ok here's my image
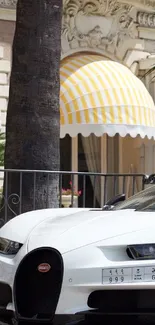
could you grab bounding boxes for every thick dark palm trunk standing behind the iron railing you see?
[4,0,62,216]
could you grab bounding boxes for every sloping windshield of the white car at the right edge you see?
[113,185,155,212]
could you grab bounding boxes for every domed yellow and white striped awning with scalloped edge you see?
[60,54,155,138]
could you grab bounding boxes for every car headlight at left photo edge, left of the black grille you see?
[0,237,22,255]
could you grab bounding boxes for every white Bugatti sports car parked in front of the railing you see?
[0,185,155,324]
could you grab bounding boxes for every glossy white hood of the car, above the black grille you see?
[27,210,155,254]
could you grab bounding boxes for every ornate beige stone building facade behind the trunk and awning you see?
[0,0,155,202]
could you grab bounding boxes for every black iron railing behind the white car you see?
[0,169,154,225]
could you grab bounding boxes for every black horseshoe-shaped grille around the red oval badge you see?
[14,248,63,321]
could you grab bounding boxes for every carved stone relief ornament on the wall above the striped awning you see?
[62,0,138,53]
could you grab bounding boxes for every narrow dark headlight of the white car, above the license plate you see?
[126,244,155,260]
